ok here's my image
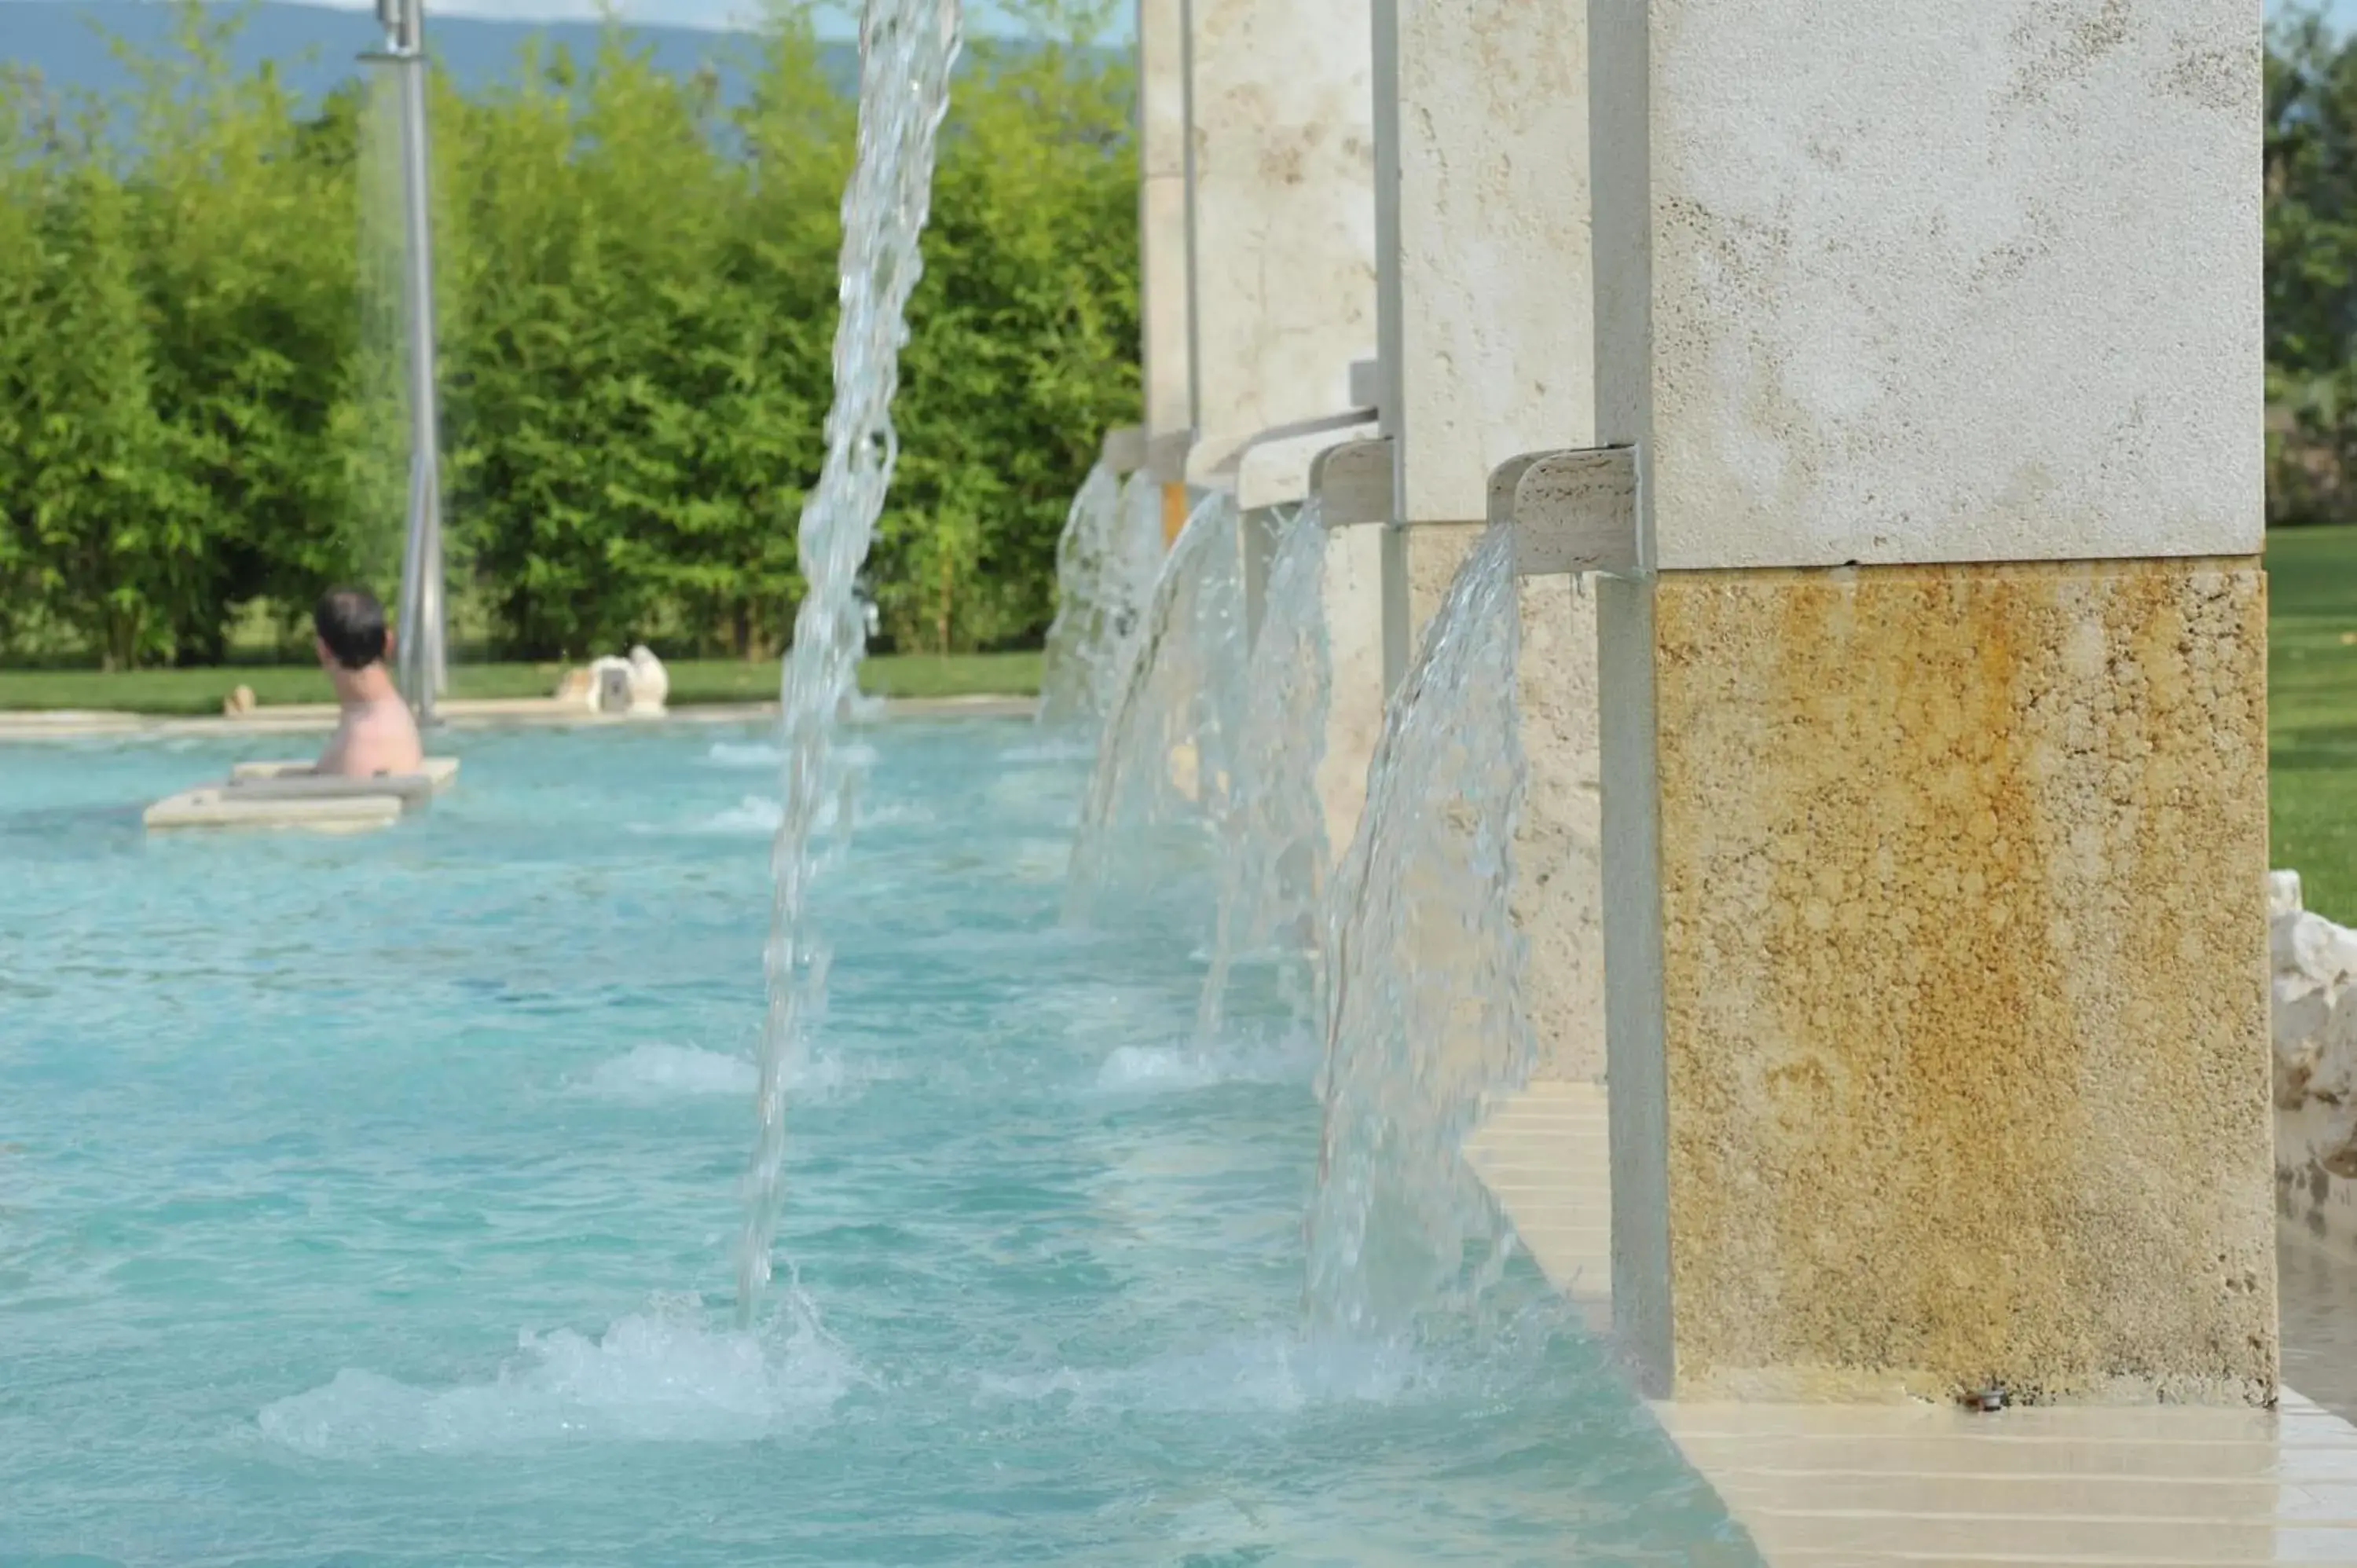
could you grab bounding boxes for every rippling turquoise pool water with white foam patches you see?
[0,724,1751,1568]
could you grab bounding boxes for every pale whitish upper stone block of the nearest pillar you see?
[1593,0,2265,570]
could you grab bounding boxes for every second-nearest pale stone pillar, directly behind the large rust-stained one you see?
[1360,0,1605,1078]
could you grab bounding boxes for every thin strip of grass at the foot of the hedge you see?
[0,653,1039,714]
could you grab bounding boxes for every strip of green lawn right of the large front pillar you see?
[2267,528,2357,925]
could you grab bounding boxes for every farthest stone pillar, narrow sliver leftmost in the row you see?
[1138,0,1195,542]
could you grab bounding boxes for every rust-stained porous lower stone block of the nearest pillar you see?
[1650,559,2277,1405]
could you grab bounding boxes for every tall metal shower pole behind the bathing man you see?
[363,0,450,724]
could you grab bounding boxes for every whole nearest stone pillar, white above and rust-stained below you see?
[1591,0,2277,1403]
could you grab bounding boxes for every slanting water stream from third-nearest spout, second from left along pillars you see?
[1068,495,1244,920]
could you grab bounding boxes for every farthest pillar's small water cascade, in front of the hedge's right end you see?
[1039,462,1162,726]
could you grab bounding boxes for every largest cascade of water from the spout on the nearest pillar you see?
[1308,528,1532,1337]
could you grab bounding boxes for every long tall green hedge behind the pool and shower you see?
[0,5,1138,667]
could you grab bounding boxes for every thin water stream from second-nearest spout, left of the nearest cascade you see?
[1195,500,1334,1040]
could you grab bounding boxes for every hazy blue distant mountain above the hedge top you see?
[0,0,858,101]
